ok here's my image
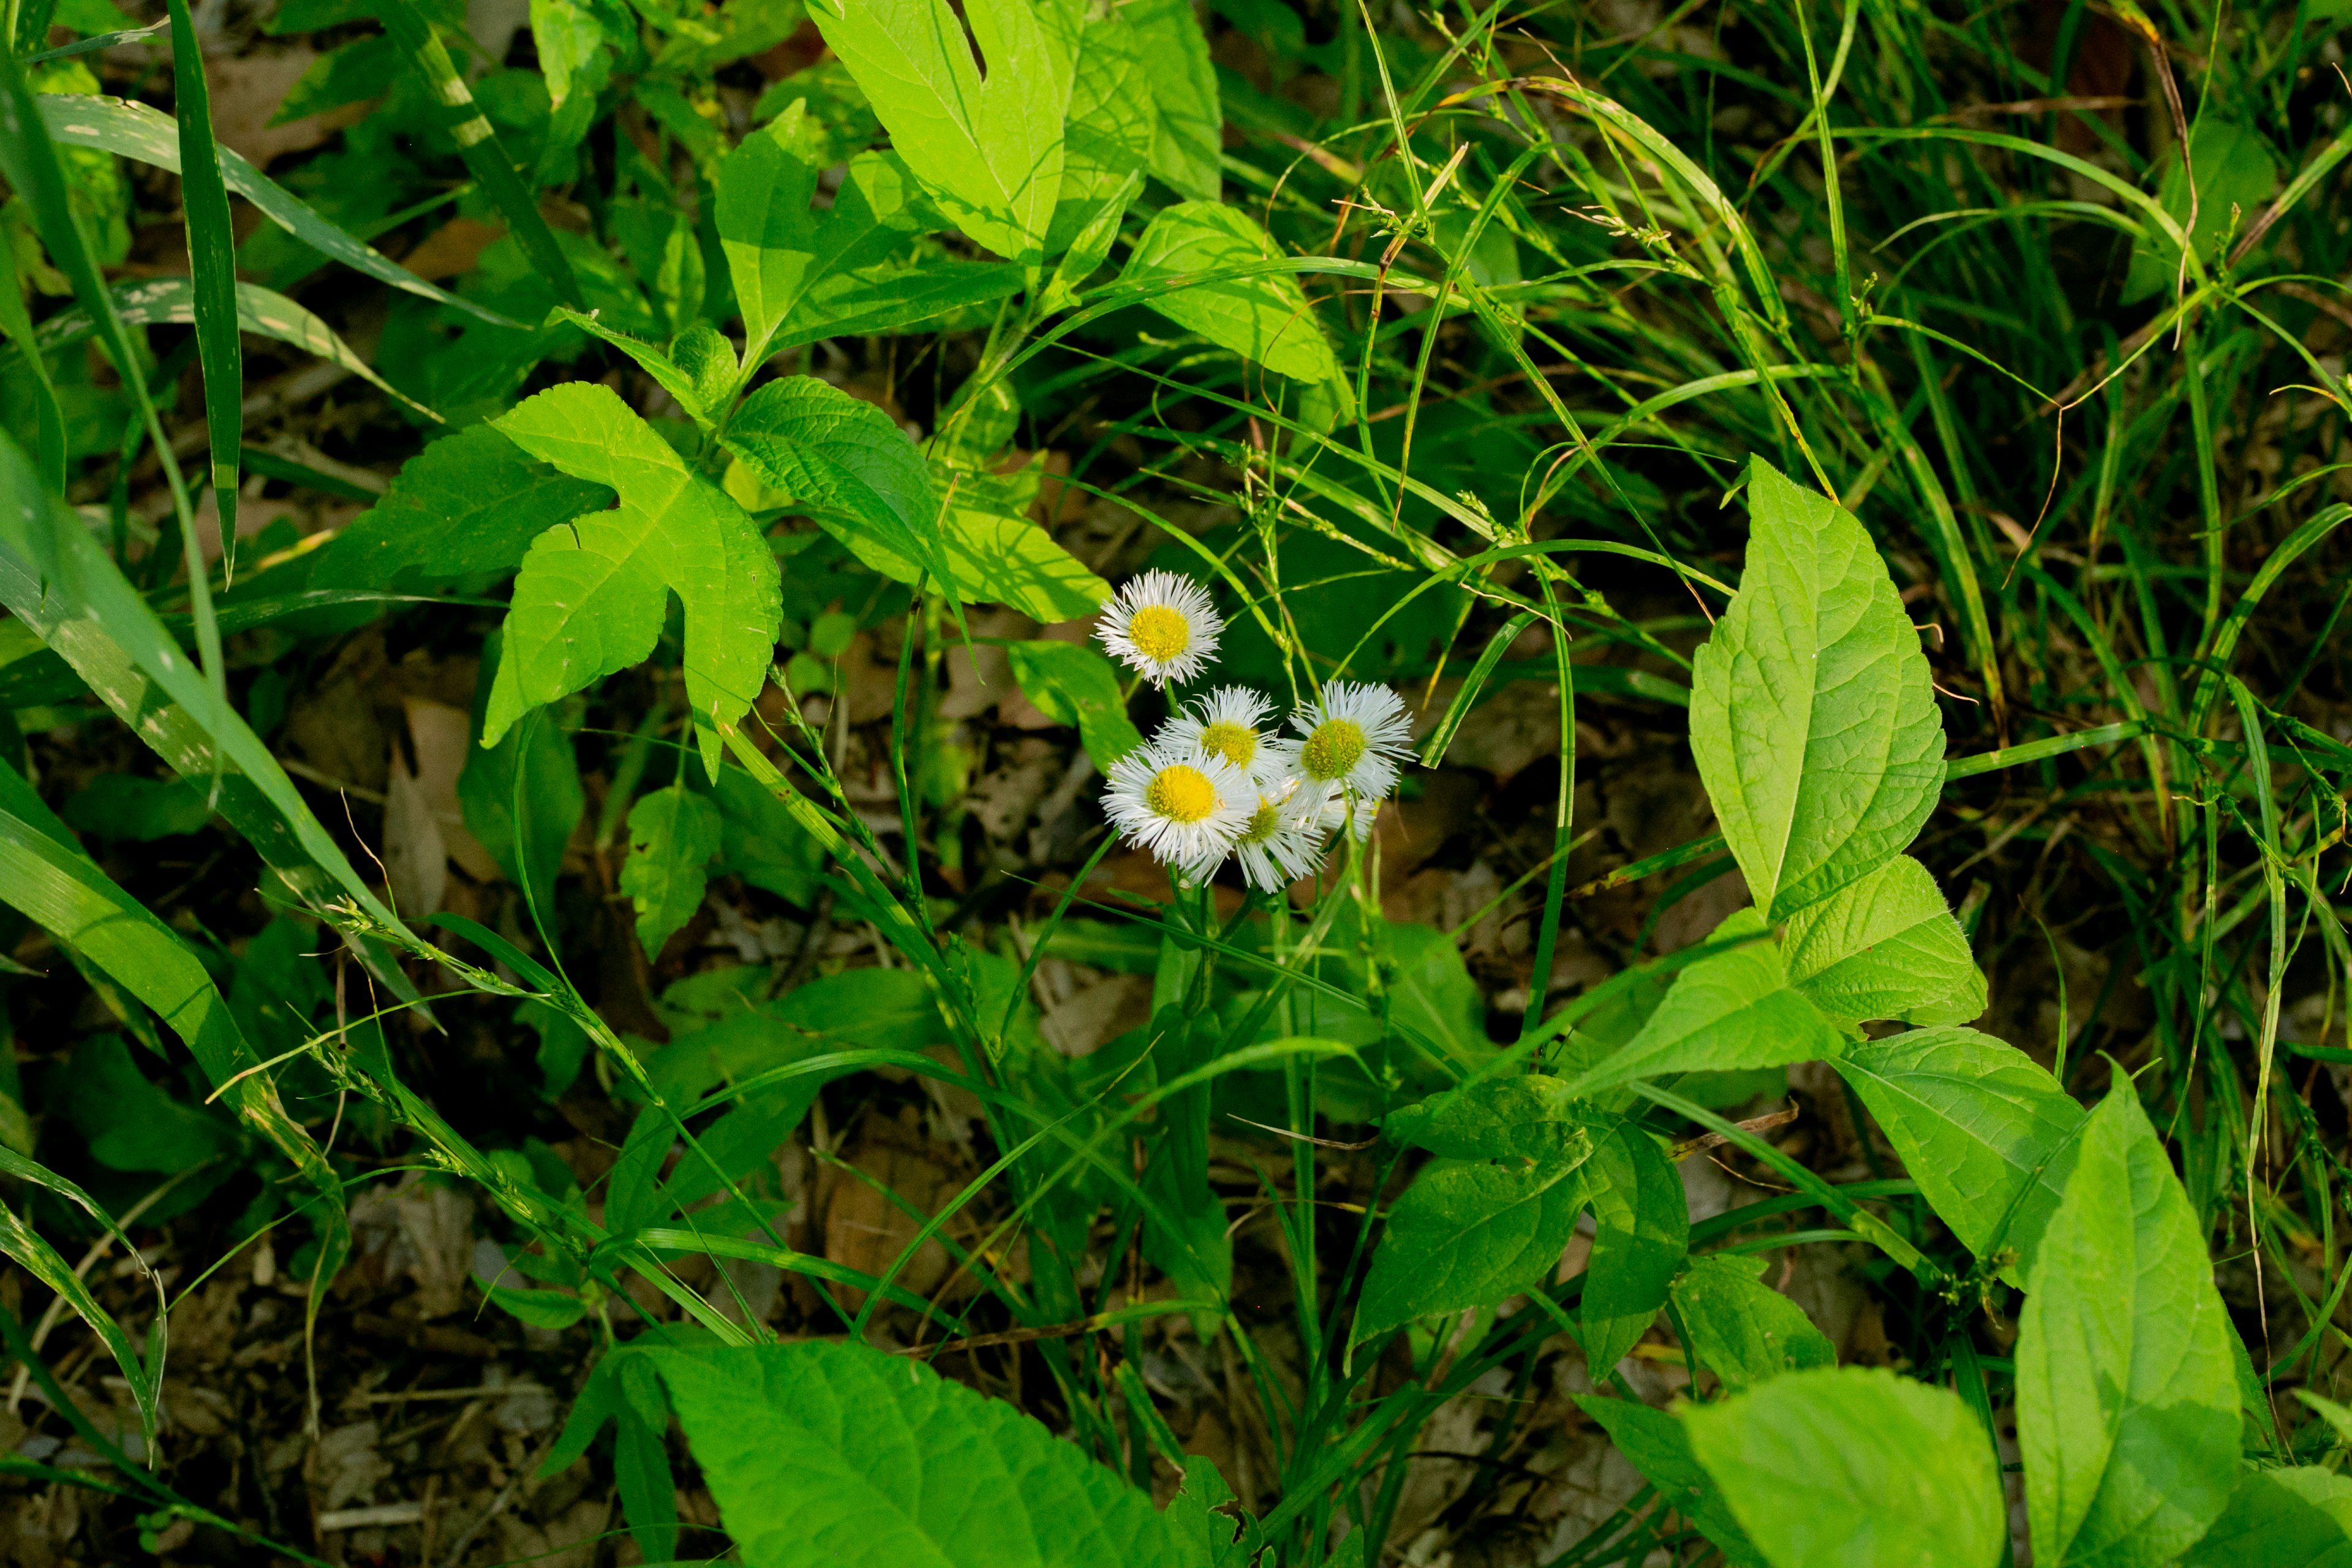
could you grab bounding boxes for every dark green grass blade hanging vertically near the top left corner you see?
[169,0,244,581]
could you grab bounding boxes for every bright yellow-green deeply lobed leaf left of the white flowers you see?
[482,381,783,778]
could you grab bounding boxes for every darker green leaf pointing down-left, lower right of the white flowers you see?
[1348,1145,1590,1344]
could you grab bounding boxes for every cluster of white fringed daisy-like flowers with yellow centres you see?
[1094,571,1414,893]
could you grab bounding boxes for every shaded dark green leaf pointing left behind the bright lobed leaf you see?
[279,426,614,592]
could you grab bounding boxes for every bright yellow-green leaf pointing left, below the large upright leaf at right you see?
[1574,910,1846,1096]
